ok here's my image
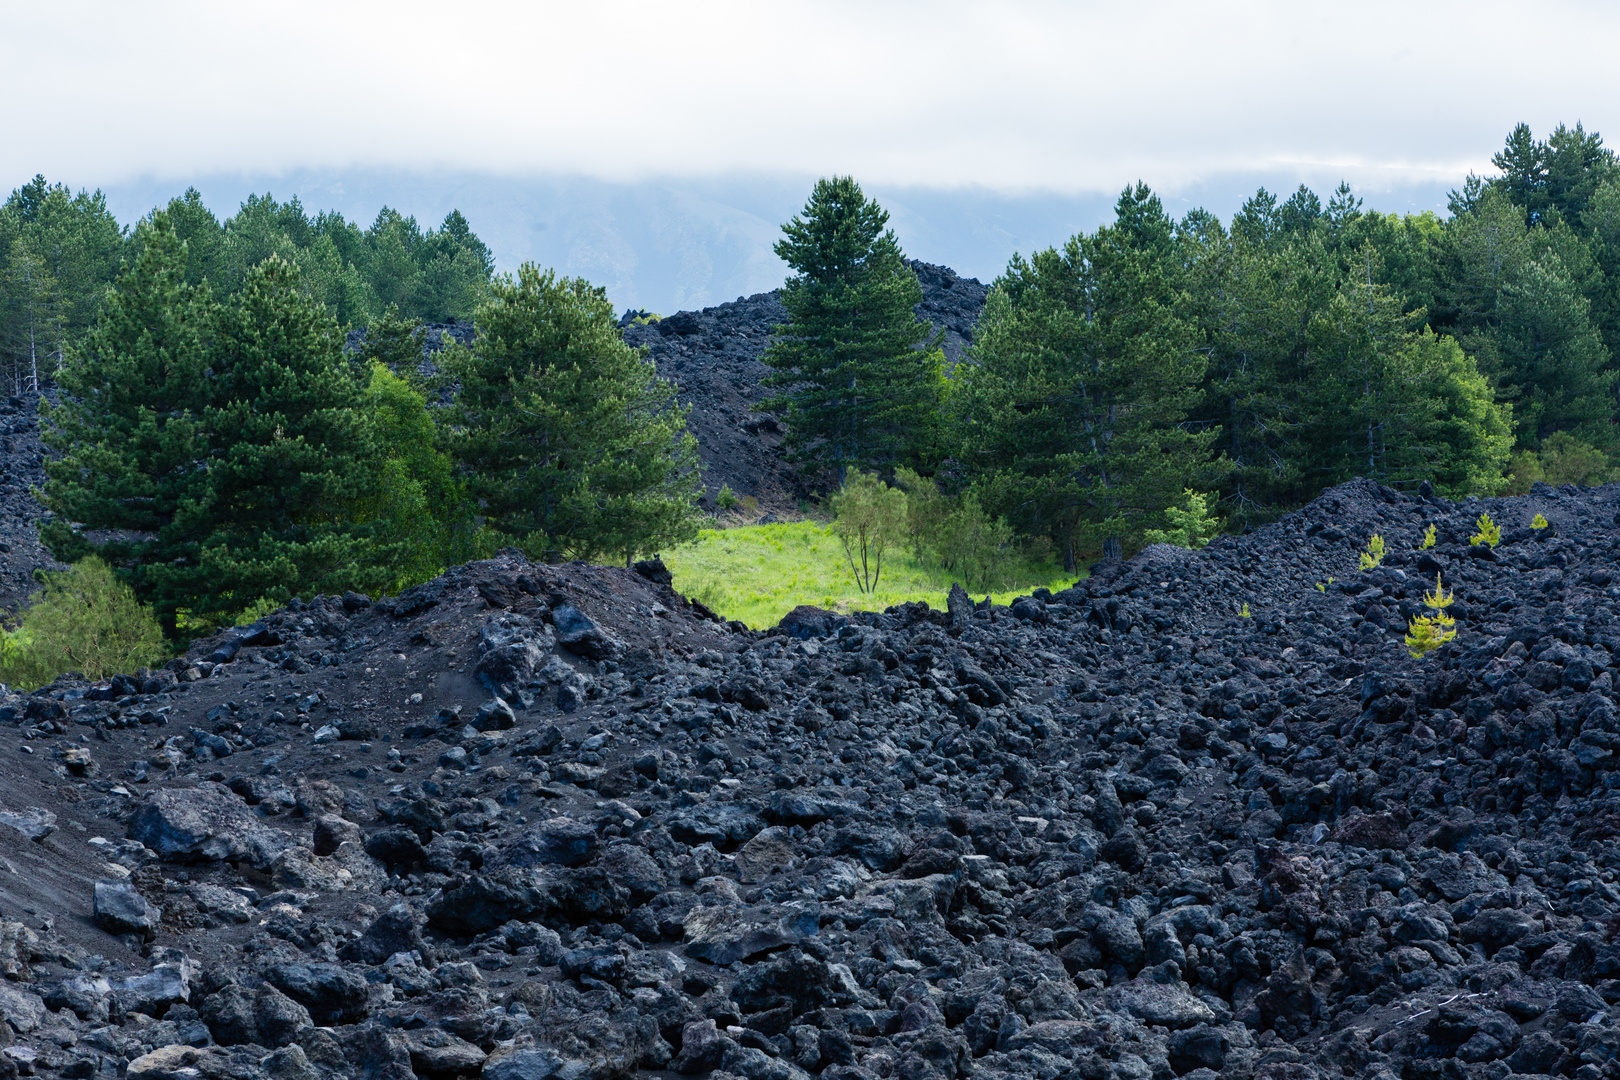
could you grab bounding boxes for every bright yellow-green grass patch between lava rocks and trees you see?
[664,521,1079,628]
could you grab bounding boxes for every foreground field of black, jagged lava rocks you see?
[0,483,1620,1080]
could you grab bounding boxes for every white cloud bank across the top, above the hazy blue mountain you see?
[0,0,1620,193]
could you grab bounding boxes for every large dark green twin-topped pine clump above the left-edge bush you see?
[41,214,431,635]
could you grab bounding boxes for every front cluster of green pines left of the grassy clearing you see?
[41,210,700,640]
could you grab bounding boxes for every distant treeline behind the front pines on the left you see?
[0,176,494,393]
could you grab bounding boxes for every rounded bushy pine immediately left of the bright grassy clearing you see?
[444,264,701,563]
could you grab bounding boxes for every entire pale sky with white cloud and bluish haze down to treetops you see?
[0,0,1620,309]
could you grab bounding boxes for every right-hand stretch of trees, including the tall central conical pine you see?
[766,125,1620,567]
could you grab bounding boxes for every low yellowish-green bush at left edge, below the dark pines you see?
[0,555,165,690]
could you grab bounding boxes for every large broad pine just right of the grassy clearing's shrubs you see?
[953,185,1217,568]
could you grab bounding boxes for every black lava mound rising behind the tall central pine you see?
[619,262,988,512]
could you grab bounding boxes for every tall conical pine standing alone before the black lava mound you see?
[761,176,944,473]
